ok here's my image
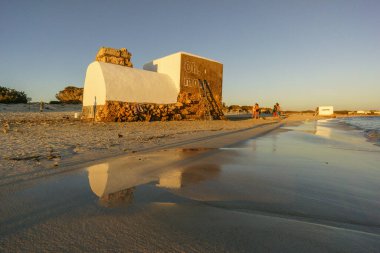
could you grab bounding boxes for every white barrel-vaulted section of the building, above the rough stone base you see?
[83,61,179,106]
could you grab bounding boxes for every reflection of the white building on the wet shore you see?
[87,154,220,207]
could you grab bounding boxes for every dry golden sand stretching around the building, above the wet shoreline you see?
[0,103,326,183]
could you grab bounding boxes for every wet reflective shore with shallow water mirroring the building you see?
[0,120,380,252]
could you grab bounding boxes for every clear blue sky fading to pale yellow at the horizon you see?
[0,0,380,110]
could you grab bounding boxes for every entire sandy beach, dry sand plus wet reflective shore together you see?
[0,106,380,252]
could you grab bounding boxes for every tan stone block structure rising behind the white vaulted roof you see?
[95,47,133,68]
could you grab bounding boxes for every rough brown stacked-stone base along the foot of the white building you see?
[82,92,222,122]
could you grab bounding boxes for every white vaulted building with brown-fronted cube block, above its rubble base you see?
[82,50,223,121]
